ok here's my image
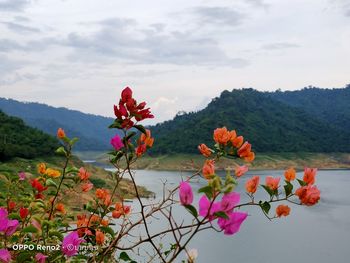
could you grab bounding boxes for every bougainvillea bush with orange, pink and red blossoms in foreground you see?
[0,88,320,263]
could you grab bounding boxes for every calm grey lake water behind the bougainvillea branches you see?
[107,170,350,263]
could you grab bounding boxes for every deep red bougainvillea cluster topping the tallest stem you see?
[114,87,154,129]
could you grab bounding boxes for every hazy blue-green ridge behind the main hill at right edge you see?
[269,84,350,130]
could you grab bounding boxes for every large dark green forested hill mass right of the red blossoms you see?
[151,87,350,154]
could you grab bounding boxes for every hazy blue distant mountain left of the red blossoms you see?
[0,98,115,151]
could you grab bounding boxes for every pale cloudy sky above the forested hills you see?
[0,0,350,124]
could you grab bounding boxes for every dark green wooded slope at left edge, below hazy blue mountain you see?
[0,111,59,161]
